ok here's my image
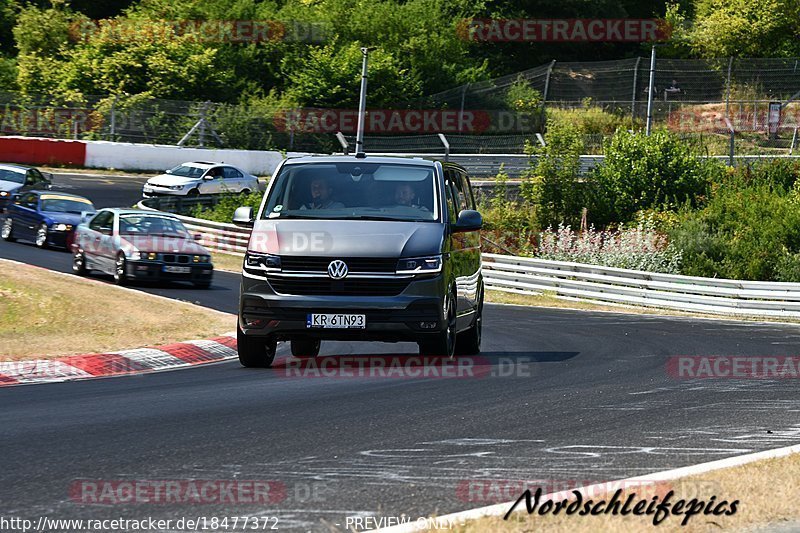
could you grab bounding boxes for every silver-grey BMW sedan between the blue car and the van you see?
[72,208,214,289]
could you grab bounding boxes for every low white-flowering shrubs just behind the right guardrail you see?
[536,218,682,274]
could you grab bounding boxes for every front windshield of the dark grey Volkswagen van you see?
[261,162,439,221]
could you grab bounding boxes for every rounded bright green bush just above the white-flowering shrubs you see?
[588,130,723,225]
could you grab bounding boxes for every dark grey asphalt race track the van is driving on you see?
[0,171,800,531]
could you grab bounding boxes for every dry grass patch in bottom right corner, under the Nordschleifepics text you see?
[432,448,800,533]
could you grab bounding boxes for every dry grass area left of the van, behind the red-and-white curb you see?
[0,261,236,361]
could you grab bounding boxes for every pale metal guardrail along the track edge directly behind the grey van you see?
[150,211,800,318]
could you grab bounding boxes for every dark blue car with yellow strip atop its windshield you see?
[0,191,96,249]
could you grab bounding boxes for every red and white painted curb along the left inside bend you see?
[0,332,237,387]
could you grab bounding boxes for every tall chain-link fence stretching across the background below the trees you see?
[0,57,800,155]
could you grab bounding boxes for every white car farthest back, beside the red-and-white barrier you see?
[142,161,260,198]
